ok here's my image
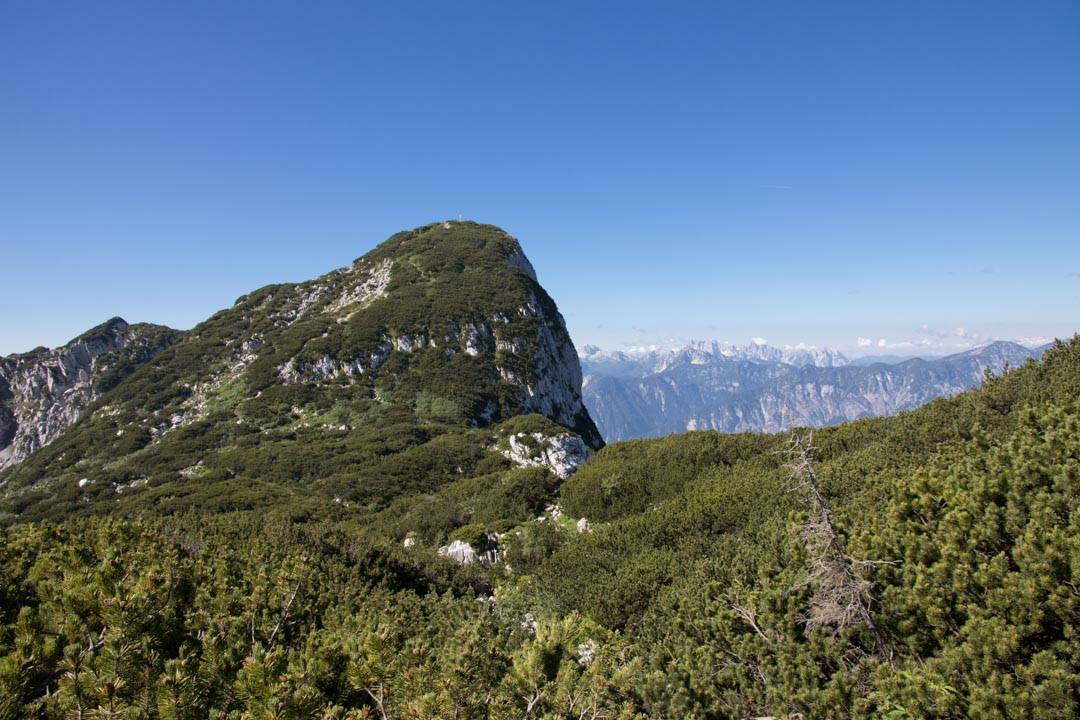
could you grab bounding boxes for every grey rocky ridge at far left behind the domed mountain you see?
[0,317,179,470]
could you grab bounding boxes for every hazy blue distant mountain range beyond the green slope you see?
[579,341,1049,443]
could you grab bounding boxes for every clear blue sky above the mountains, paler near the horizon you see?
[0,0,1080,353]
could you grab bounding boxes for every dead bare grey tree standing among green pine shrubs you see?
[787,432,892,663]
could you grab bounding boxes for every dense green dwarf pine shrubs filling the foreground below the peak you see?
[0,341,1080,718]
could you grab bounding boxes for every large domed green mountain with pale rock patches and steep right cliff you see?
[0,222,603,521]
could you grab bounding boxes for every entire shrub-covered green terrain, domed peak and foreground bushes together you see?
[0,223,1080,720]
